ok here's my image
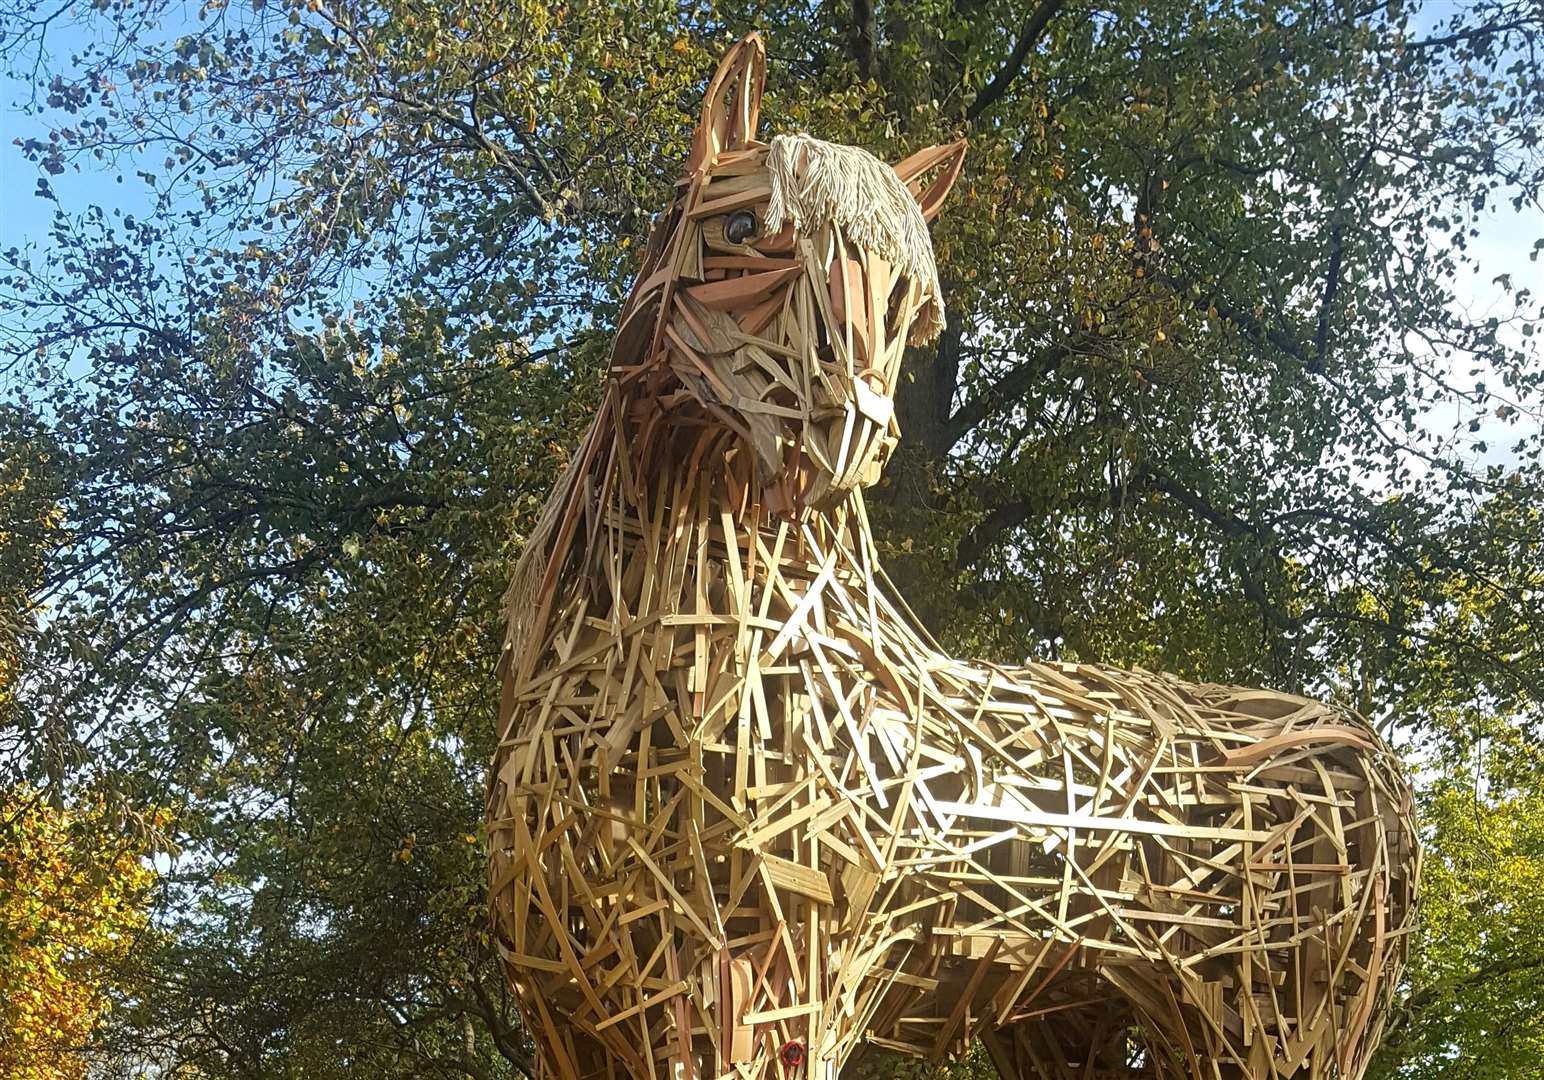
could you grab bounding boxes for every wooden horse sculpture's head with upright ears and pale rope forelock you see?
[611,34,965,513]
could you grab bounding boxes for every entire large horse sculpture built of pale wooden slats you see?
[488,36,1419,1080]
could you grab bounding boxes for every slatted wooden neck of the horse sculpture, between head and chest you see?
[505,384,936,684]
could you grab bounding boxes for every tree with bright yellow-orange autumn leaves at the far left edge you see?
[0,408,154,1080]
